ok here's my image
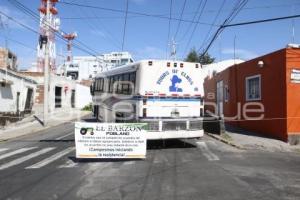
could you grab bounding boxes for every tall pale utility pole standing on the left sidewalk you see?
[43,0,50,126]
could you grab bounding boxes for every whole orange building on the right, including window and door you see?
[204,47,300,143]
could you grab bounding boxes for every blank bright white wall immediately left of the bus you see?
[75,83,92,109]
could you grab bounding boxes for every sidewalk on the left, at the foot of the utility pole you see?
[0,109,91,141]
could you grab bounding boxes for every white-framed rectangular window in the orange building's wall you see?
[246,75,261,101]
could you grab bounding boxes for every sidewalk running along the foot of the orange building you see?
[207,126,300,152]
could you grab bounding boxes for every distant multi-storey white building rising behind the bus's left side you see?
[57,52,133,80]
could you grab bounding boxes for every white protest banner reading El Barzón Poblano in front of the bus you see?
[75,122,147,158]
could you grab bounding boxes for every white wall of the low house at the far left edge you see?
[0,69,37,114]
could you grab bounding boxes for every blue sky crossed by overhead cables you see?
[0,0,300,68]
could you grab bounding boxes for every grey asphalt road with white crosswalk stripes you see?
[0,118,300,200]
